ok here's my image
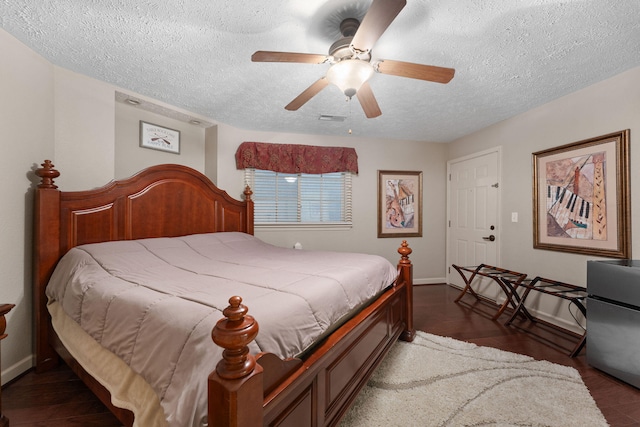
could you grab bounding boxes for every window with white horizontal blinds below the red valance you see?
[245,168,351,227]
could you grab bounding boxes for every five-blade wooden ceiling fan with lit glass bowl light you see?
[251,0,455,118]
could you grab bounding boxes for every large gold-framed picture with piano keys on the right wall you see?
[533,129,631,258]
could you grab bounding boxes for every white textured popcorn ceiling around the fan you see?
[0,0,640,142]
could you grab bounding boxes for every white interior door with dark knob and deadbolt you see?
[447,148,500,299]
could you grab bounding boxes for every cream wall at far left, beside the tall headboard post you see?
[0,30,54,382]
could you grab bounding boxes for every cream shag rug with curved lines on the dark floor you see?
[340,332,608,427]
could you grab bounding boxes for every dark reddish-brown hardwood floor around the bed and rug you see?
[2,285,640,427]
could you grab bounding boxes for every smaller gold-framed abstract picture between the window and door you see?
[378,170,422,237]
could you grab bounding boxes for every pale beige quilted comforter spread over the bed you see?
[47,232,397,426]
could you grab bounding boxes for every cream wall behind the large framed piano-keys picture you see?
[448,64,640,332]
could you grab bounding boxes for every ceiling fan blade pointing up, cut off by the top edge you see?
[351,0,407,52]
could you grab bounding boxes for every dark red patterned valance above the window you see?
[236,142,358,174]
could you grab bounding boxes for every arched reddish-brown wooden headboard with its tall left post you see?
[33,160,253,371]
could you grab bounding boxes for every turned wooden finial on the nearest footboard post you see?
[211,296,259,380]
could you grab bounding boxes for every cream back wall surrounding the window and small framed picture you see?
[218,125,447,283]
